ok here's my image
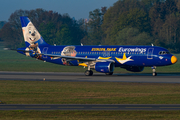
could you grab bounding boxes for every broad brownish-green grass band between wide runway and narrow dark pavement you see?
[0,80,180,104]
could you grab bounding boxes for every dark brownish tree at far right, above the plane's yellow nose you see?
[149,0,180,52]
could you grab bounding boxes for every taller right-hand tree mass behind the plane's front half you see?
[83,0,180,52]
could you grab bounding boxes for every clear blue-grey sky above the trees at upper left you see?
[0,0,118,21]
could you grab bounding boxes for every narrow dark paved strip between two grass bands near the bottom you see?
[0,104,180,111]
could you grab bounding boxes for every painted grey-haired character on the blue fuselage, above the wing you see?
[61,46,77,65]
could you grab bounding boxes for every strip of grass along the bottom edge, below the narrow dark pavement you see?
[0,110,180,120]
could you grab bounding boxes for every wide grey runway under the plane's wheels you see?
[0,72,180,83]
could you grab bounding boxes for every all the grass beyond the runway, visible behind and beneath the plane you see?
[0,49,180,73]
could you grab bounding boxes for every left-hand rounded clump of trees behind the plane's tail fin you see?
[0,9,85,48]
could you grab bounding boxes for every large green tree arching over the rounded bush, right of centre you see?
[101,0,151,44]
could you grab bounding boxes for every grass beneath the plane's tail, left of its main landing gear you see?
[0,50,84,72]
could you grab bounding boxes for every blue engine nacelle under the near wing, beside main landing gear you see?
[95,62,114,73]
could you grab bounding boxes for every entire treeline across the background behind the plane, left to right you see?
[0,0,180,52]
